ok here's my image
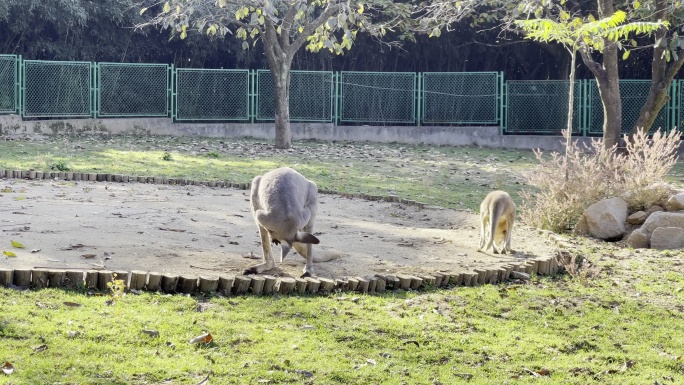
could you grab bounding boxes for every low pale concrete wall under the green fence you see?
[0,115,587,151]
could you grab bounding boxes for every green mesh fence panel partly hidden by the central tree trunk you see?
[255,70,335,122]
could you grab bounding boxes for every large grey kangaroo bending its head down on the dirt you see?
[244,167,339,278]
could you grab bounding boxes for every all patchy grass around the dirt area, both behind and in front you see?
[0,137,684,385]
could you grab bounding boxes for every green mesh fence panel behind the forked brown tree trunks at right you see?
[586,79,673,134]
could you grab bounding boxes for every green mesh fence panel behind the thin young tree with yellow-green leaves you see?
[504,80,585,134]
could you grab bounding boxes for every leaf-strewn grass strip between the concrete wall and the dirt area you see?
[0,136,536,210]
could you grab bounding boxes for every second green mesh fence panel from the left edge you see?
[22,60,94,118]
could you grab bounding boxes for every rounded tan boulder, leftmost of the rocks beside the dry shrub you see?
[580,197,627,239]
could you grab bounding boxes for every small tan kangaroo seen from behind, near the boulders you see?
[477,191,515,254]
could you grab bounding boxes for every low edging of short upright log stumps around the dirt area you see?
[0,170,572,296]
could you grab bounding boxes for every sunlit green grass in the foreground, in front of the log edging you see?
[0,250,684,384]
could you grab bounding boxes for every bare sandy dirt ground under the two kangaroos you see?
[0,179,554,278]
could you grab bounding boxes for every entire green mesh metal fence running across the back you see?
[0,55,684,135]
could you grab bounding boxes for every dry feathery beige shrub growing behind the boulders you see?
[520,130,680,232]
